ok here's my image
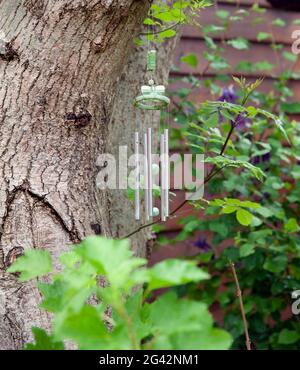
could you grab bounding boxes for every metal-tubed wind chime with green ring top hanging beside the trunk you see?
[134,50,170,221]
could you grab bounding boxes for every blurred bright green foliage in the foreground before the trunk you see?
[10,236,232,350]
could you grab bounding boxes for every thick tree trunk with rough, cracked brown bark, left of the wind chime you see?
[0,0,148,349]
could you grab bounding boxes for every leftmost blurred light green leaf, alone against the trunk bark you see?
[7,249,52,281]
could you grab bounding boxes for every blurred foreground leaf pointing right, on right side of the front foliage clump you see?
[148,259,209,290]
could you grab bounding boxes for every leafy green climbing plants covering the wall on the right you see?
[168,4,300,349]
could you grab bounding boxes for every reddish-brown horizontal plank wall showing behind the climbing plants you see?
[151,0,300,263]
